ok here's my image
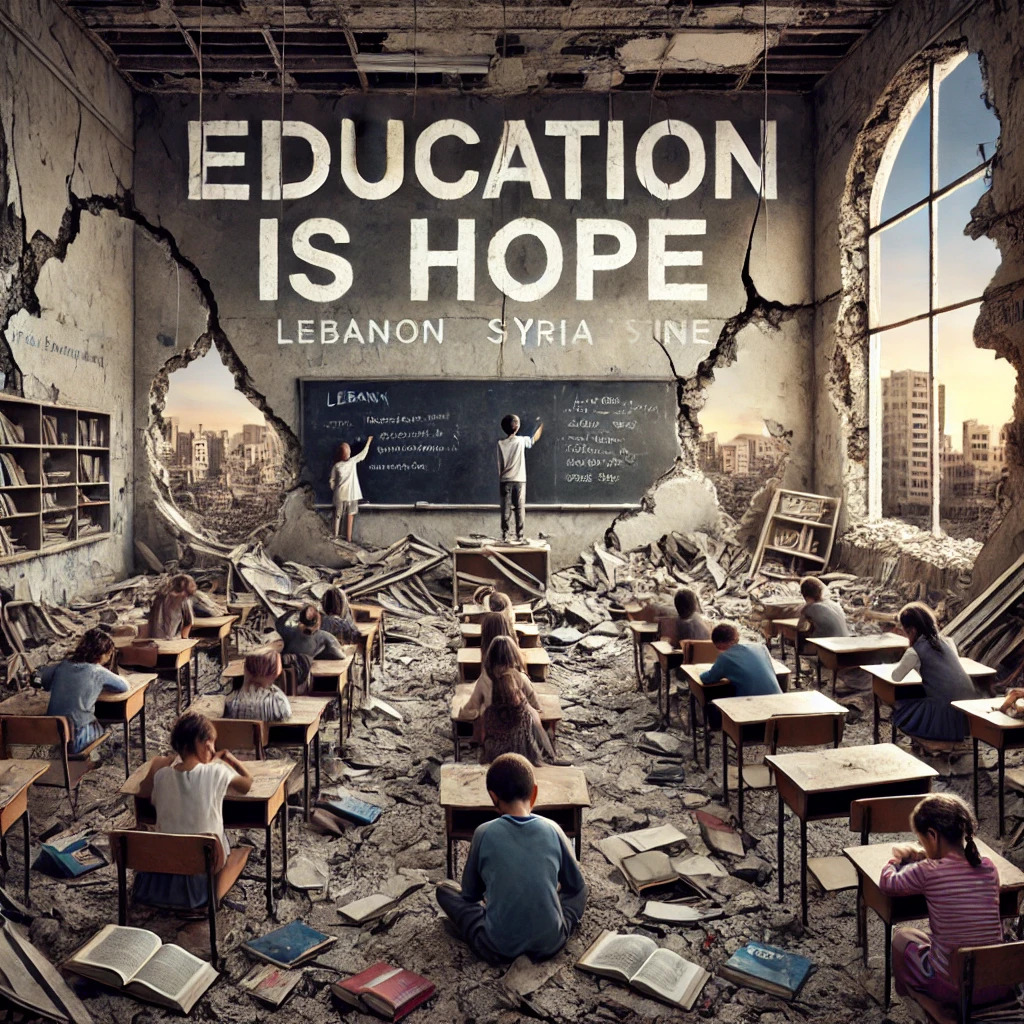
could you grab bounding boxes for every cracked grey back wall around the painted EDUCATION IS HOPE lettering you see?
[134,94,812,560]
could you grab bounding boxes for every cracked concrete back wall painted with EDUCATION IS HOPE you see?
[135,94,813,560]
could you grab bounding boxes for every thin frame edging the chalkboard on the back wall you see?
[296,375,673,512]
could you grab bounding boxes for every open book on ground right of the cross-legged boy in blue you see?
[577,931,711,1010]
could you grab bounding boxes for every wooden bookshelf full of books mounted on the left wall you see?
[0,394,111,564]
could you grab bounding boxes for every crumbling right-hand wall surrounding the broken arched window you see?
[815,0,1024,592]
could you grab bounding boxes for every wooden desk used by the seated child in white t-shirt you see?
[121,758,295,914]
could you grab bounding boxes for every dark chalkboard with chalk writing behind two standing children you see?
[299,379,679,505]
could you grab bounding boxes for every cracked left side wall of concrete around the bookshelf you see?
[0,0,134,600]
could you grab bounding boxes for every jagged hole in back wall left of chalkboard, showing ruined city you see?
[157,347,293,542]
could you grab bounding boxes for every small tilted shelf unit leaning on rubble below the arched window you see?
[751,488,842,575]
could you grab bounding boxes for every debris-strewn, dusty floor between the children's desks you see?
[14,618,1021,1024]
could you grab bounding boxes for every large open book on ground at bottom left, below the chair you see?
[63,925,217,1014]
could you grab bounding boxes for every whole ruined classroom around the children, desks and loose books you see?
[6,0,1024,1024]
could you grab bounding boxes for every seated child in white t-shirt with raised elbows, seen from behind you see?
[135,711,253,909]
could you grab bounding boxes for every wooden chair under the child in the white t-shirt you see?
[109,829,252,968]
